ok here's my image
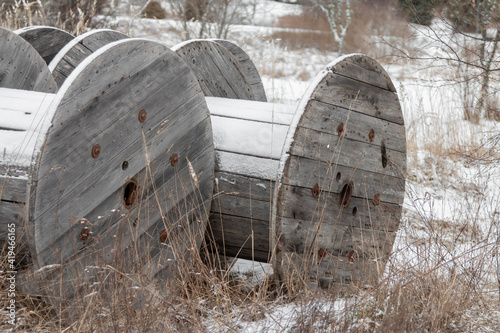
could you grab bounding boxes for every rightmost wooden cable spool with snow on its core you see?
[175,41,406,288]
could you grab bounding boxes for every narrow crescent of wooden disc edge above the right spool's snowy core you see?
[212,39,267,102]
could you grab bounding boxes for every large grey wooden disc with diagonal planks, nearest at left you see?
[30,39,214,303]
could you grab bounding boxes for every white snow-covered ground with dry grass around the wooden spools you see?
[0,1,500,332]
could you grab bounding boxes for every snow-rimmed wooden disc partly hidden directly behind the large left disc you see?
[49,29,128,86]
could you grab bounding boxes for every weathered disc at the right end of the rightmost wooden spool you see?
[272,55,406,288]
